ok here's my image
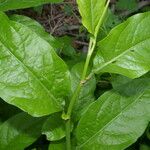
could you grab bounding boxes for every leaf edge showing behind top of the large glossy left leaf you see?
[9,15,61,53]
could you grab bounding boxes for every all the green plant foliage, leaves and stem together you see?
[0,0,150,150]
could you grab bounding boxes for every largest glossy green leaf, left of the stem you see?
[0,12,70,116]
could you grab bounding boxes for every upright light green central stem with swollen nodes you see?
[64,0,110,150]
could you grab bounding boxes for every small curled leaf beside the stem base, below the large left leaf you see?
[42,113,65,141]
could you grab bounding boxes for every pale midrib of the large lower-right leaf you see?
[79,91,145,148]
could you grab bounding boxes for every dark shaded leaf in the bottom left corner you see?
[0,113,45,150]
